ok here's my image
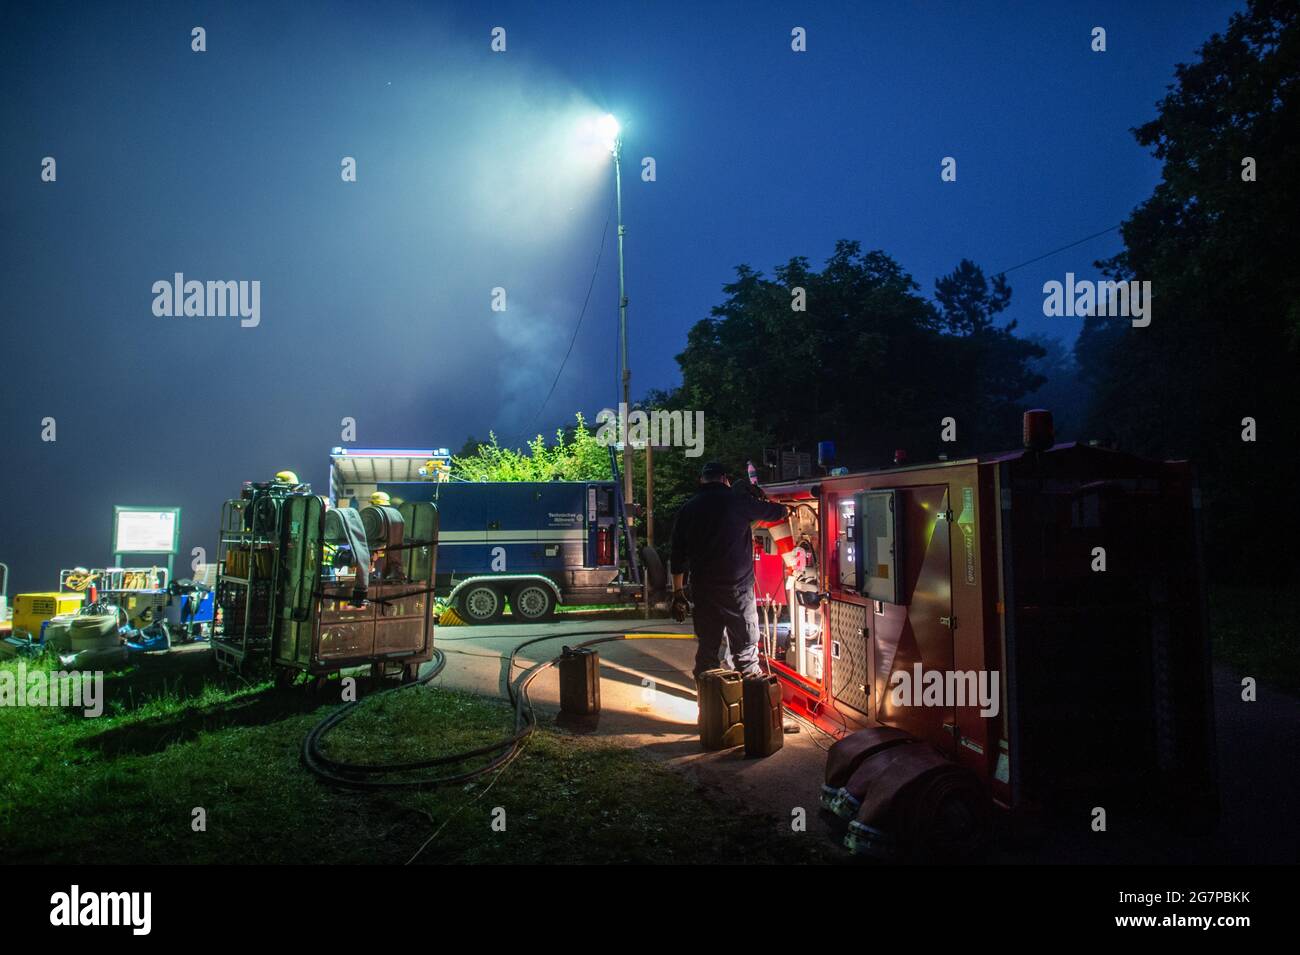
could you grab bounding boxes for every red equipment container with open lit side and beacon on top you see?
[757,418,1216,808]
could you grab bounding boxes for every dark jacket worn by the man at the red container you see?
[672,483,785,587]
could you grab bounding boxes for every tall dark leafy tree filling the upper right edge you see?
[1075,0,1300,573]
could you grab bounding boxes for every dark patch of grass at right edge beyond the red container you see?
[1209,587,1300,693]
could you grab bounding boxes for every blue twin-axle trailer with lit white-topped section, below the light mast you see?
[329,448,642,624]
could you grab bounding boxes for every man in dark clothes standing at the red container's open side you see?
[672,461,787,680]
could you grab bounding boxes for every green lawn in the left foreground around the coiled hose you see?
[0,652,839,863]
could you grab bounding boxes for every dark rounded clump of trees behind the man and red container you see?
[673,240,1040,466]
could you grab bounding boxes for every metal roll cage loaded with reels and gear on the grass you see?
[212,481,438,681]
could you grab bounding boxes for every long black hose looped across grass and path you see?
[302,628,680,789]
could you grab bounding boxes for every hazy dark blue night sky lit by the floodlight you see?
[0,3,1238,594]
